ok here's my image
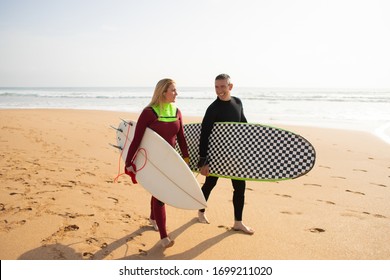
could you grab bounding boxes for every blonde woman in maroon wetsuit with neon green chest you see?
[125,79,189,248]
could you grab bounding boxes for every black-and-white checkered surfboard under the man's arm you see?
[176,123,316,181]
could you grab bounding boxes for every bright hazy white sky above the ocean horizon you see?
[0,0,390,88]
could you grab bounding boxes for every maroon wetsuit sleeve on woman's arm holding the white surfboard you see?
[126,108,156,167]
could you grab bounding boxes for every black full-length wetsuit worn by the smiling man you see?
[199,96,247,221]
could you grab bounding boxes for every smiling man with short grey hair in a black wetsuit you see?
[198,74,255,234]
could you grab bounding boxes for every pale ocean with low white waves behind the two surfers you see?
[0,87,390,144]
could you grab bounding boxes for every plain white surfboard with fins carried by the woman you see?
[116,121,206,210]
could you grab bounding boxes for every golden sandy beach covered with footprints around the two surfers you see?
[0,110,390,260]
